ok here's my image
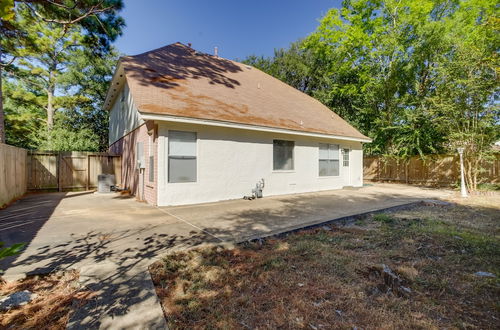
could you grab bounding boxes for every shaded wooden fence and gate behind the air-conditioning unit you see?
[27,151,121,191]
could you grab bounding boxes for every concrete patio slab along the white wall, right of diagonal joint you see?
[161,184,452,242]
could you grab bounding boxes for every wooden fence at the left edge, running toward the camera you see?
[0,143,27,207]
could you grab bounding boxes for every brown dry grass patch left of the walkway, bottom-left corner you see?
[0,271,90,330]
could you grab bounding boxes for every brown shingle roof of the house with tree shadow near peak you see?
[108,43,369,141]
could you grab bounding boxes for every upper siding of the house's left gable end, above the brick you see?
[109,84,144,145]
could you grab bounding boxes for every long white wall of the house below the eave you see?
[157,122,363,206]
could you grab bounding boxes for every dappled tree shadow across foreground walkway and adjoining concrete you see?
[7,225,218,329]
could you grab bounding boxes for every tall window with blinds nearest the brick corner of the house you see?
[168,131,196,183]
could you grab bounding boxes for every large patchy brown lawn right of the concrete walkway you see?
[151,195,500,329]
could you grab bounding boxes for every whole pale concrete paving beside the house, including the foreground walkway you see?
[0,184,450,329]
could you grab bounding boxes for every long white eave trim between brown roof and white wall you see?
[139,111,372,143]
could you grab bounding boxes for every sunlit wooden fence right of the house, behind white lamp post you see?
[363,155,500,186]
